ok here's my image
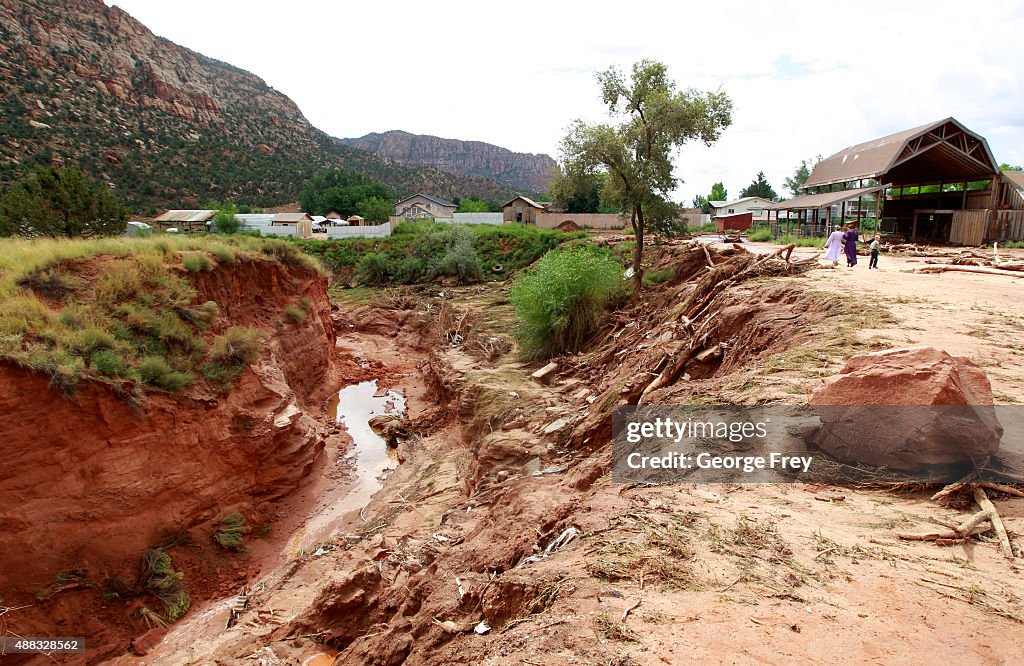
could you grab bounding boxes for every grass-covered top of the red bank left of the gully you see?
[0,236,318,400]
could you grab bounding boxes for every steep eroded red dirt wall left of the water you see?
[0,257,336,663]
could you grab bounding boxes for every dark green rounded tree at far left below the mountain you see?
[0,167,128,238]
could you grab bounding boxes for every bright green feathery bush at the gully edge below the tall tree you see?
[509,247,626,359]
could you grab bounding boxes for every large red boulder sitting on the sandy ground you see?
[808,347,1002,472]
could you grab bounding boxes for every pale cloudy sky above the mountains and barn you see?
[108,0,1024,201]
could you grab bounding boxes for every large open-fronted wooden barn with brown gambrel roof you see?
[766,118,1024,245]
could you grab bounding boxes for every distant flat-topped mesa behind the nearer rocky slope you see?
[341,130,555,193]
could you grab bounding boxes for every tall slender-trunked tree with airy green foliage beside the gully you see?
[561,59,732,292]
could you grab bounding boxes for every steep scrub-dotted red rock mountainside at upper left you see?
[0,0,512,212]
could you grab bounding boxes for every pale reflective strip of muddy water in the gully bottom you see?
[289,379,406,556]
